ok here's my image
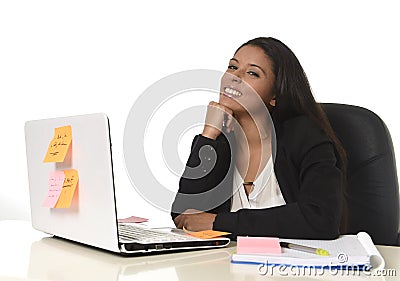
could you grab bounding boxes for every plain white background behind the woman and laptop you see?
[0,0,400,224]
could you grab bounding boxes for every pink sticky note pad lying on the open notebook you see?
[237,236,282,254]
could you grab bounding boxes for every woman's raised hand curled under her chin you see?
[202,101,233,140]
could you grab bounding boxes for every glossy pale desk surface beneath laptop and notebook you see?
[0,221,400,281]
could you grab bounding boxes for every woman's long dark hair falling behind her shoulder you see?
[236,37,347,233]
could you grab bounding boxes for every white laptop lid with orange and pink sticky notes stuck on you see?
[25,113,119,252]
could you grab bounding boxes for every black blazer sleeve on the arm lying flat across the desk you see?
[213,118,342,239]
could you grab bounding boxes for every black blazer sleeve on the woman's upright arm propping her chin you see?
[171,134,232,219]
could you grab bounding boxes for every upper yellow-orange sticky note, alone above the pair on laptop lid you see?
[43,126,72,162]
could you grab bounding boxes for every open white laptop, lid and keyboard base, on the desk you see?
[25,113,230,255]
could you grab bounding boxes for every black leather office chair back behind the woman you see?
[321,103,400,245]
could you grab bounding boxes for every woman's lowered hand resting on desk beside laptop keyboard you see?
[174,209,217,231]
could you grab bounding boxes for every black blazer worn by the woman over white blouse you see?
[171,116,342,239]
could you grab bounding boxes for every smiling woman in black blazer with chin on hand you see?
[172,37,345,239]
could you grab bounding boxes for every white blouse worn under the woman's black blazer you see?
[231,157,286,212]
